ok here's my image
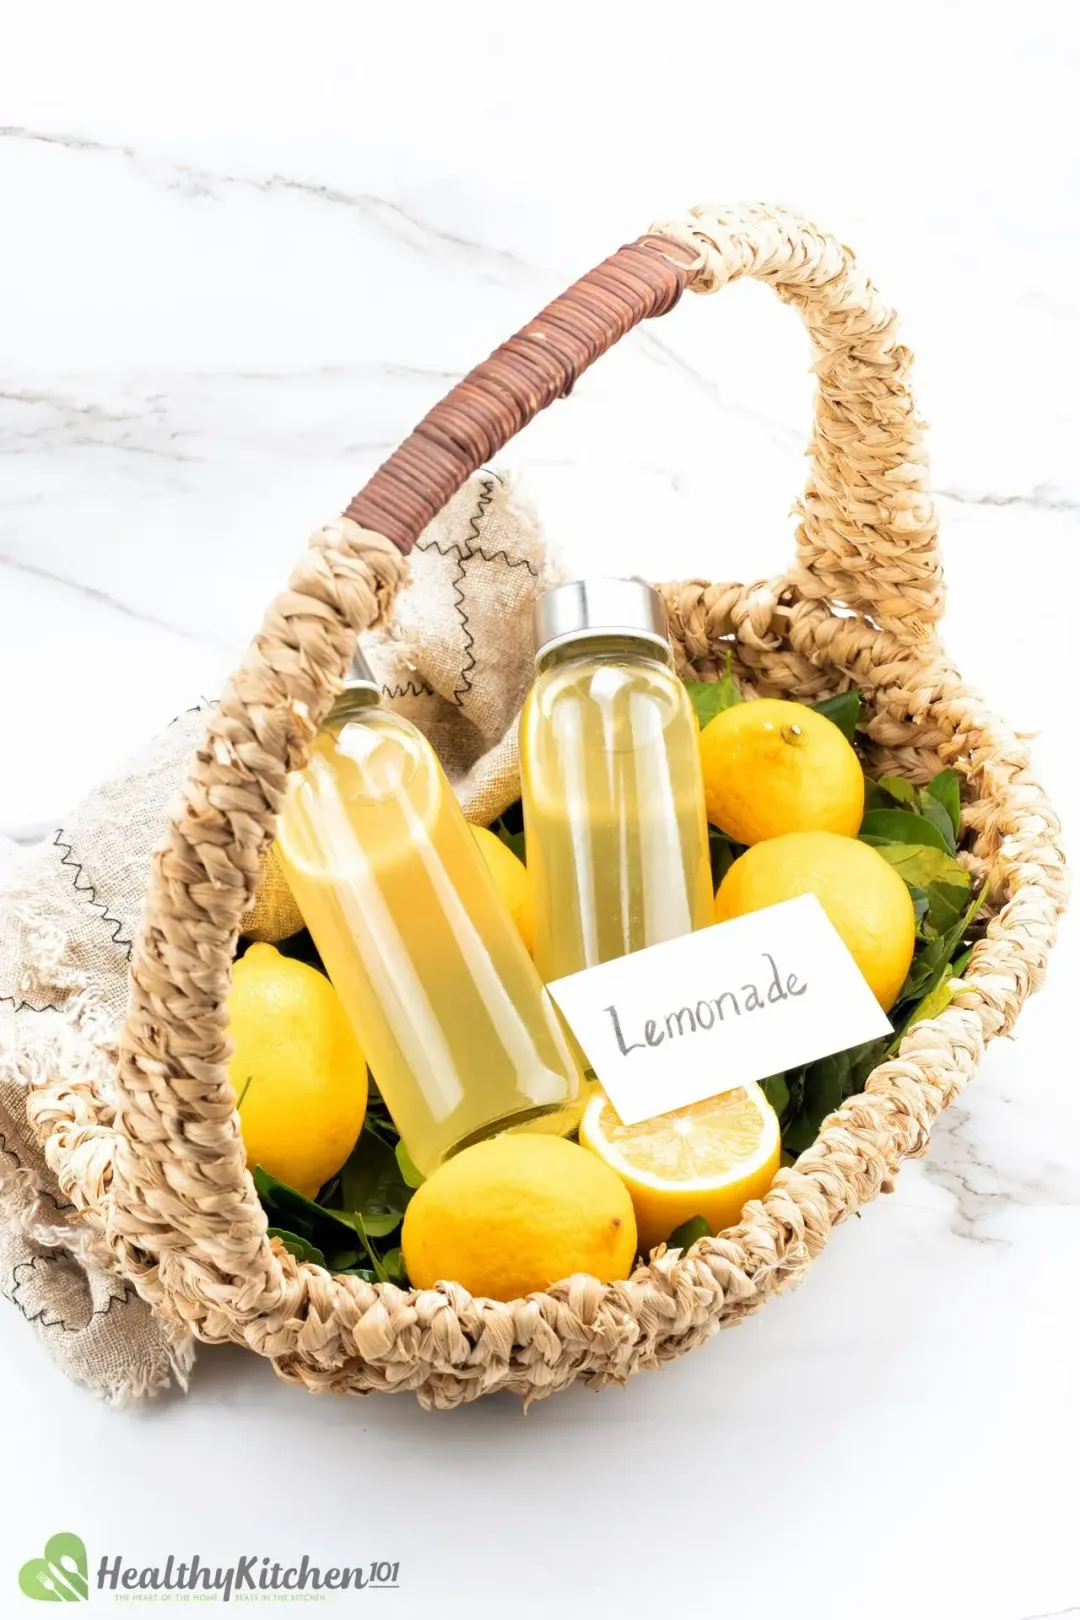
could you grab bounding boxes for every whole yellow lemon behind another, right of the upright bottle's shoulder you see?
[699,698,865,844]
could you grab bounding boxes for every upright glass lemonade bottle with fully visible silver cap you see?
[521,578,712,982]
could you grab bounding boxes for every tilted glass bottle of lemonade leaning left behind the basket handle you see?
[279,654,583,1175]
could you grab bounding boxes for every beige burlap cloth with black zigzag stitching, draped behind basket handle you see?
[0,471,557,1403]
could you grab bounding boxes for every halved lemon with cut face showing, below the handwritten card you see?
[580,1085,780,1254]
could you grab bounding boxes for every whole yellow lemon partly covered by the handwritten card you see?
[716,833,915,1013]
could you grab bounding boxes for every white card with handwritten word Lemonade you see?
[547,894,892,1124]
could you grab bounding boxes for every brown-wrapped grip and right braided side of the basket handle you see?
[345,207,944,645]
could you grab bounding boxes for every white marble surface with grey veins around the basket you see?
[0,9,1080,1620]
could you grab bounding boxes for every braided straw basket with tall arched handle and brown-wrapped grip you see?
[34,207,1065,1406]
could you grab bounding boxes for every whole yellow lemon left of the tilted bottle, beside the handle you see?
[228,944,368,1197]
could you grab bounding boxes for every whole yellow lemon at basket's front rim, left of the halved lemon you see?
[402,1136,638,1299]
